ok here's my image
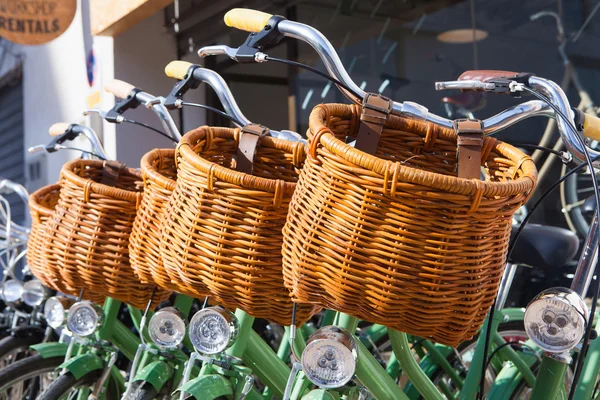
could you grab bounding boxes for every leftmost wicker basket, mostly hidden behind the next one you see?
[27,184,104,304]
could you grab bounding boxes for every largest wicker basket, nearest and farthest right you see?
[283,104,537,346]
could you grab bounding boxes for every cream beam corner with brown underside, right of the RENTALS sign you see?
[90,0,173,36]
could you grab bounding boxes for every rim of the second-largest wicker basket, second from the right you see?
[176,125,306,194]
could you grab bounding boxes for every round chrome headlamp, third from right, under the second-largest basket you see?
[189,307,238,355]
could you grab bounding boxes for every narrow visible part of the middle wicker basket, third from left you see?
[129,149,177,297]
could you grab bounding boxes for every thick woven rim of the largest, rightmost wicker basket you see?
[308,103,537,196]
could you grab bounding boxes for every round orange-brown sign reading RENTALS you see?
[0,0,77,44]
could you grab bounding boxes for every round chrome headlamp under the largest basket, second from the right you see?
[302,326,358,389]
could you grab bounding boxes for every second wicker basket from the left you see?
[41,160,161,308]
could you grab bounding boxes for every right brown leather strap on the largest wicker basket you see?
[454,119,483,179]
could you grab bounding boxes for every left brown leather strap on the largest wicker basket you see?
[354,93,394,154]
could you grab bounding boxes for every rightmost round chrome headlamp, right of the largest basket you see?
[524,288,589,353]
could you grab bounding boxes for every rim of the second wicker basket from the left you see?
[60,159,142,202]
